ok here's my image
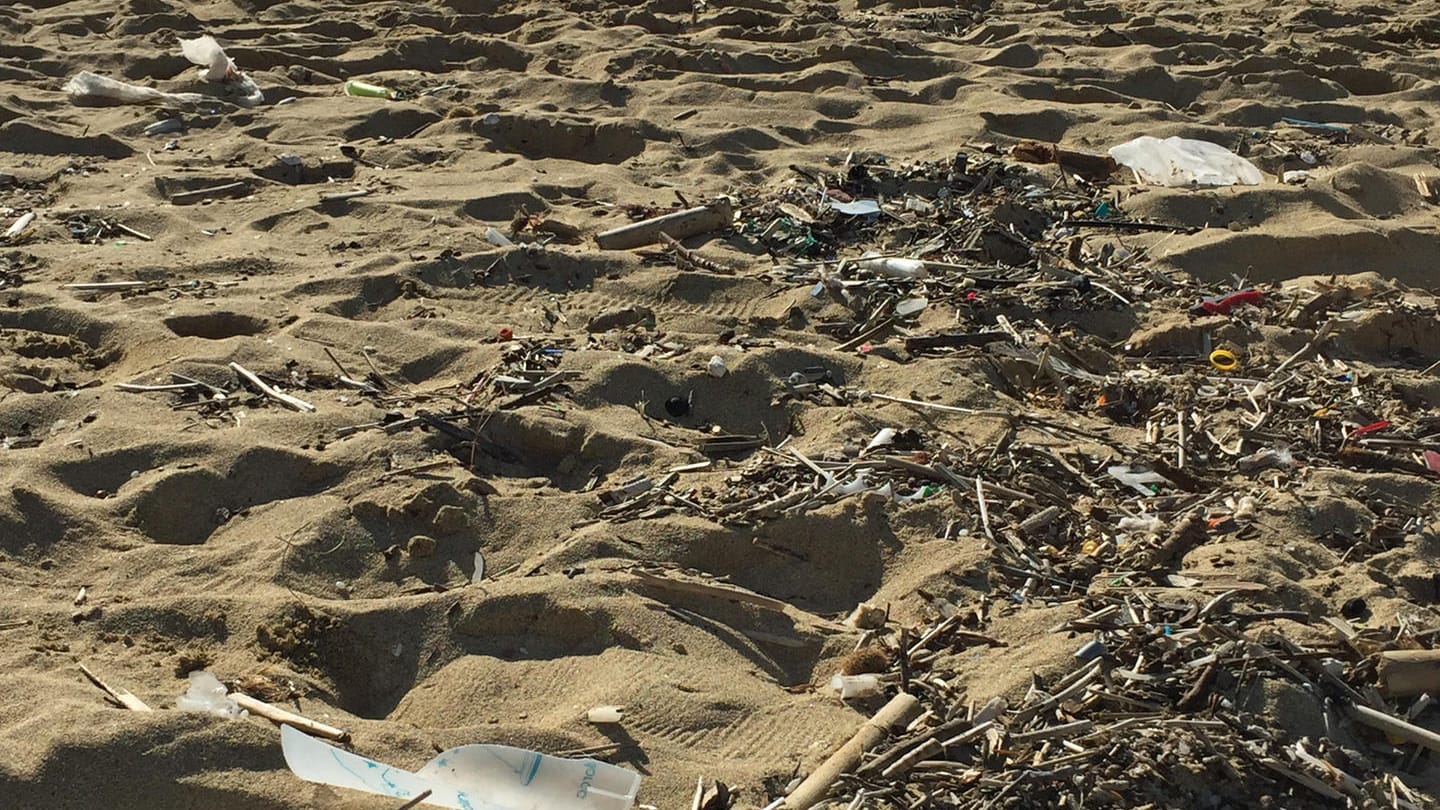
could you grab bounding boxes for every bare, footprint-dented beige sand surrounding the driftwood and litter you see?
[0,0,1440,810]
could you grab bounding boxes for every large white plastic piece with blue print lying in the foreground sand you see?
[279,725,639,810]
